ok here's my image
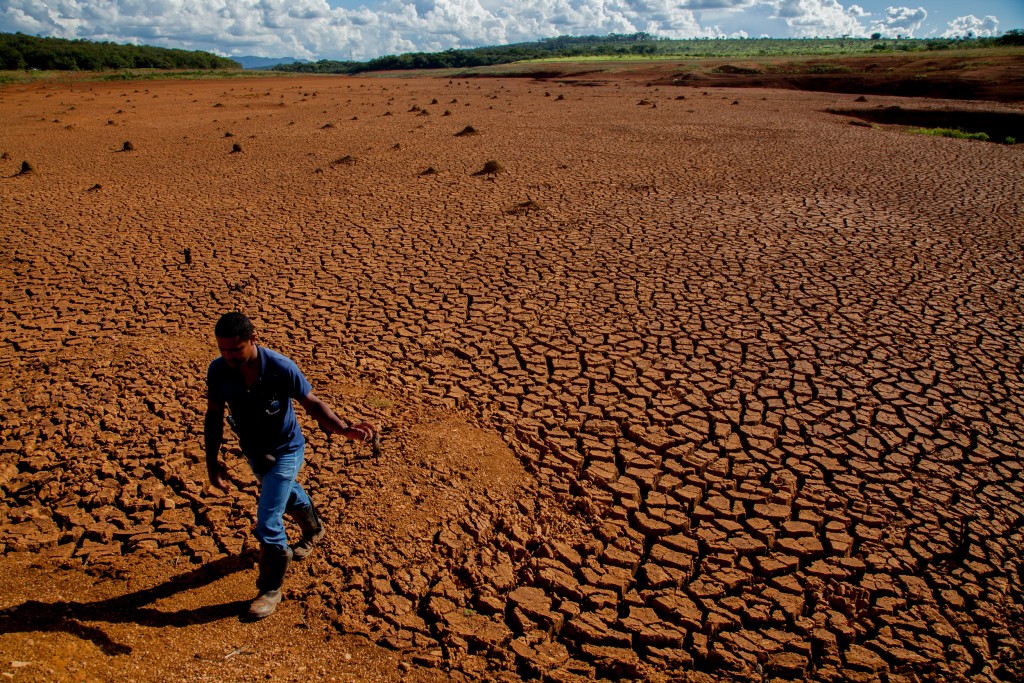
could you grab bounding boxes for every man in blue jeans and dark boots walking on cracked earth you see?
[204,312,374,618]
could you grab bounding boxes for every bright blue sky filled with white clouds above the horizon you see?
[0,0,1024,59]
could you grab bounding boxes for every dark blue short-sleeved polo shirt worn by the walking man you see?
[206,346,312,458]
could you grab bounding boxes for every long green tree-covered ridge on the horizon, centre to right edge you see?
[273,29,1024,74]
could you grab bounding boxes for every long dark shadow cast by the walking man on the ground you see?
[0,555,252,655]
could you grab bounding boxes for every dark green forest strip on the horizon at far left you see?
[0,33,242,71]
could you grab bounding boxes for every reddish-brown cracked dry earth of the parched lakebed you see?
[0,78,1024,683]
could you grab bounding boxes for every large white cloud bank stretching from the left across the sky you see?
[0,0,729,59]
